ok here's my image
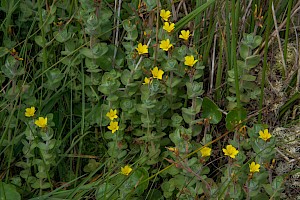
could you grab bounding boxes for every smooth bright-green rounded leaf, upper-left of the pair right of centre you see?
[202,97,222,124]
